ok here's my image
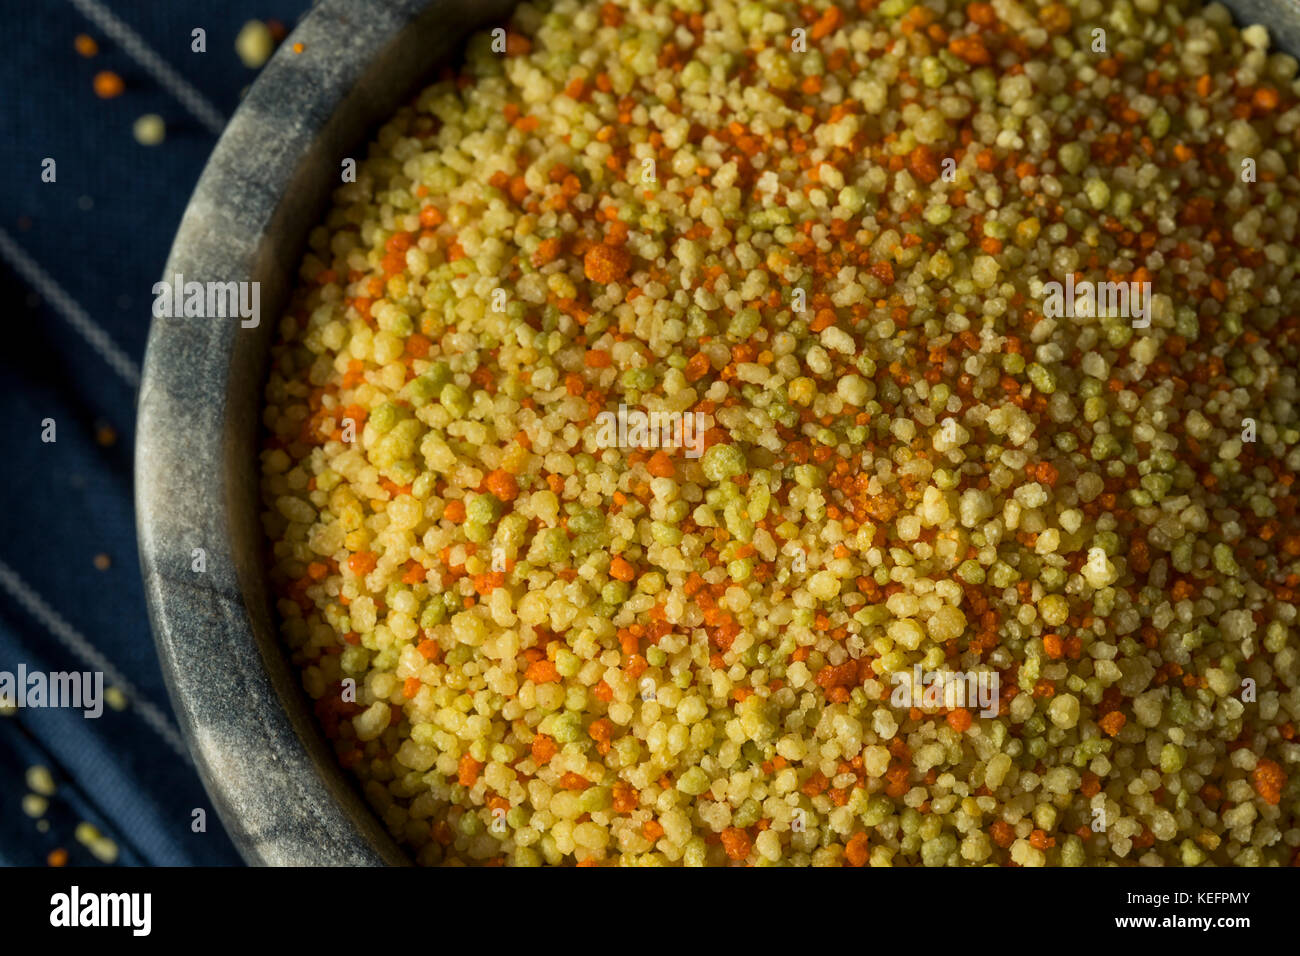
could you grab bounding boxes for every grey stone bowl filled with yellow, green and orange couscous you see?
[138,0,1300,866]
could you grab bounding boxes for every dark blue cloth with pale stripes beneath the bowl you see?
[0,0,312,865]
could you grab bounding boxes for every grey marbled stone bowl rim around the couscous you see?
[135,0,1300,865]
